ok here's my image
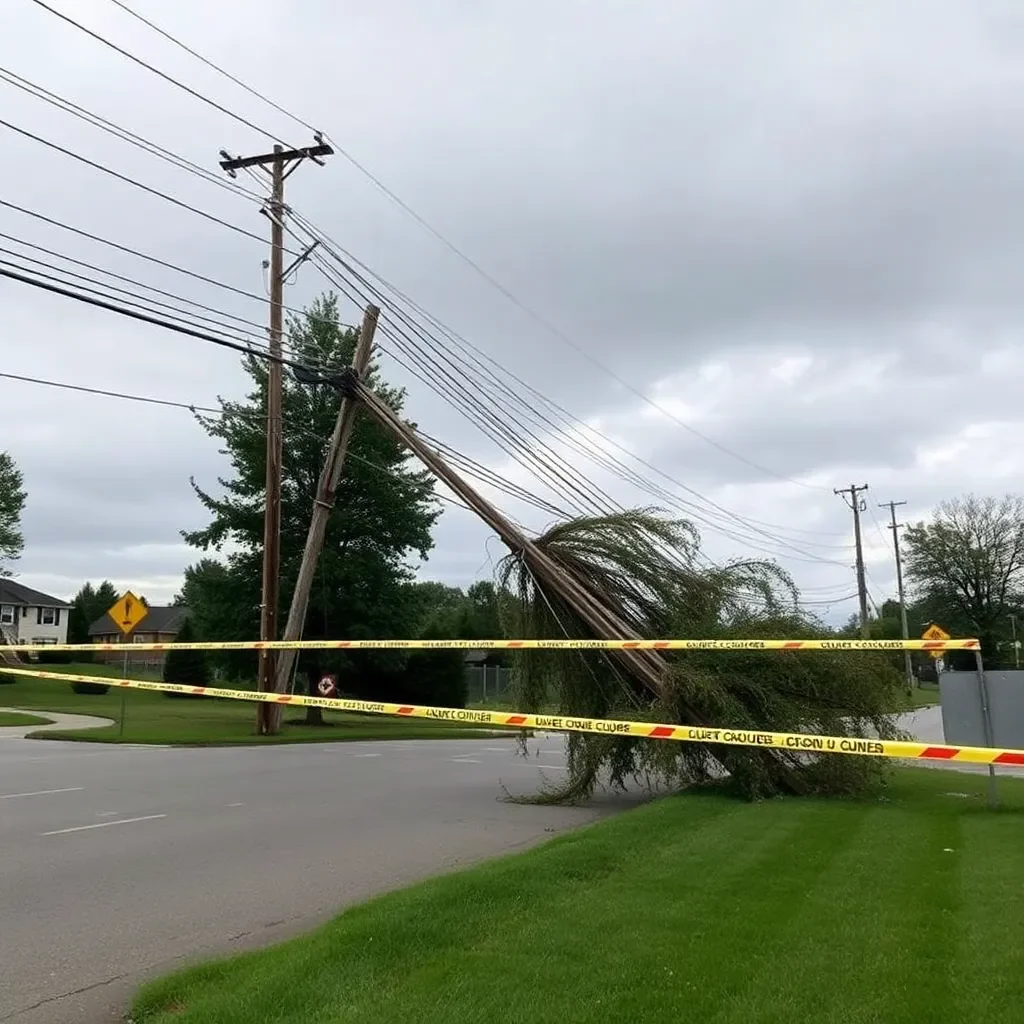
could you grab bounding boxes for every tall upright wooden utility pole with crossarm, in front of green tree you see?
[220,135,334,733]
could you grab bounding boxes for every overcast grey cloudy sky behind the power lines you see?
[0,0,1024,620]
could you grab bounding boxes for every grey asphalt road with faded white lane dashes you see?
[0,736,640,1024]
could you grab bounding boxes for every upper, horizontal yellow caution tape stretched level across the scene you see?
[2,640,980,653]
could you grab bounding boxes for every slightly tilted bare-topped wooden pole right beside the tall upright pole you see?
[268,305,381,731]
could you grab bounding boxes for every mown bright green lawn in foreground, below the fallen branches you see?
[133,769,1024,1024]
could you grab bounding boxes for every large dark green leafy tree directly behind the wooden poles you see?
[183,295,440,721]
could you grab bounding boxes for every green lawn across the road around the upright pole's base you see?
[0,665,512,745]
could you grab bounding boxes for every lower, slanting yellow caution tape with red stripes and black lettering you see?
[0,668,1024,766]
